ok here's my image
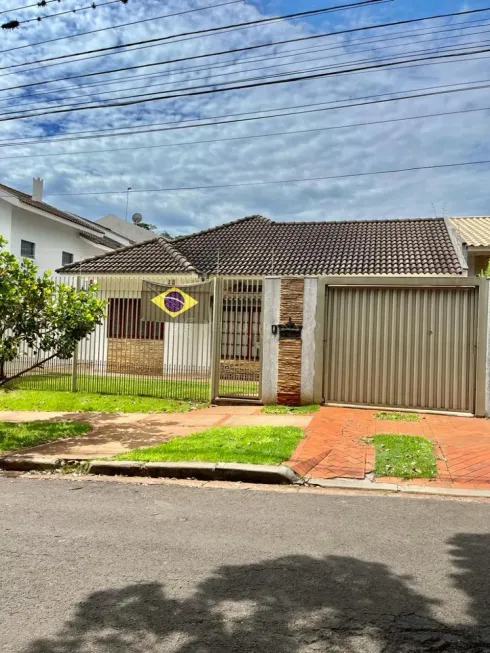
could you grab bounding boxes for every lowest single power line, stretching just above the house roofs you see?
[34,159,490,197]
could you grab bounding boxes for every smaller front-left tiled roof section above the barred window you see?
[57,237,195,274]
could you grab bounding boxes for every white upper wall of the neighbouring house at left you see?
[5,202,101,272]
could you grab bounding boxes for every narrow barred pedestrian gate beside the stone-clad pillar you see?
[215,278,263,399]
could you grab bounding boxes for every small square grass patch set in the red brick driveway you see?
[373,434,437,478]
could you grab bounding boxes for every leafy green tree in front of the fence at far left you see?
[0,236,105,386]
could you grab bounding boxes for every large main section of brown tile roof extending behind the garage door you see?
[56,216,462,275]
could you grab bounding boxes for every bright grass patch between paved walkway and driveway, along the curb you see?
[115,426,303,465]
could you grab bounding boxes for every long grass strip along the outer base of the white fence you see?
[0,390,204,413]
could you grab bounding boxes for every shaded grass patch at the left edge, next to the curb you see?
[0,422,92,451]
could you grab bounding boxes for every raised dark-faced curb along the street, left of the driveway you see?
[0,456,301,485]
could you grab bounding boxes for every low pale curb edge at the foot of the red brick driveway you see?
[306,478,490,499]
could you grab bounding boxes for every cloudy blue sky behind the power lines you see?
[0,0,490,233]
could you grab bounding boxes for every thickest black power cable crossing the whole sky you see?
[0,48,490,122]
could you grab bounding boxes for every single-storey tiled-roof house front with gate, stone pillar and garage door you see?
[52,216,490,415]
